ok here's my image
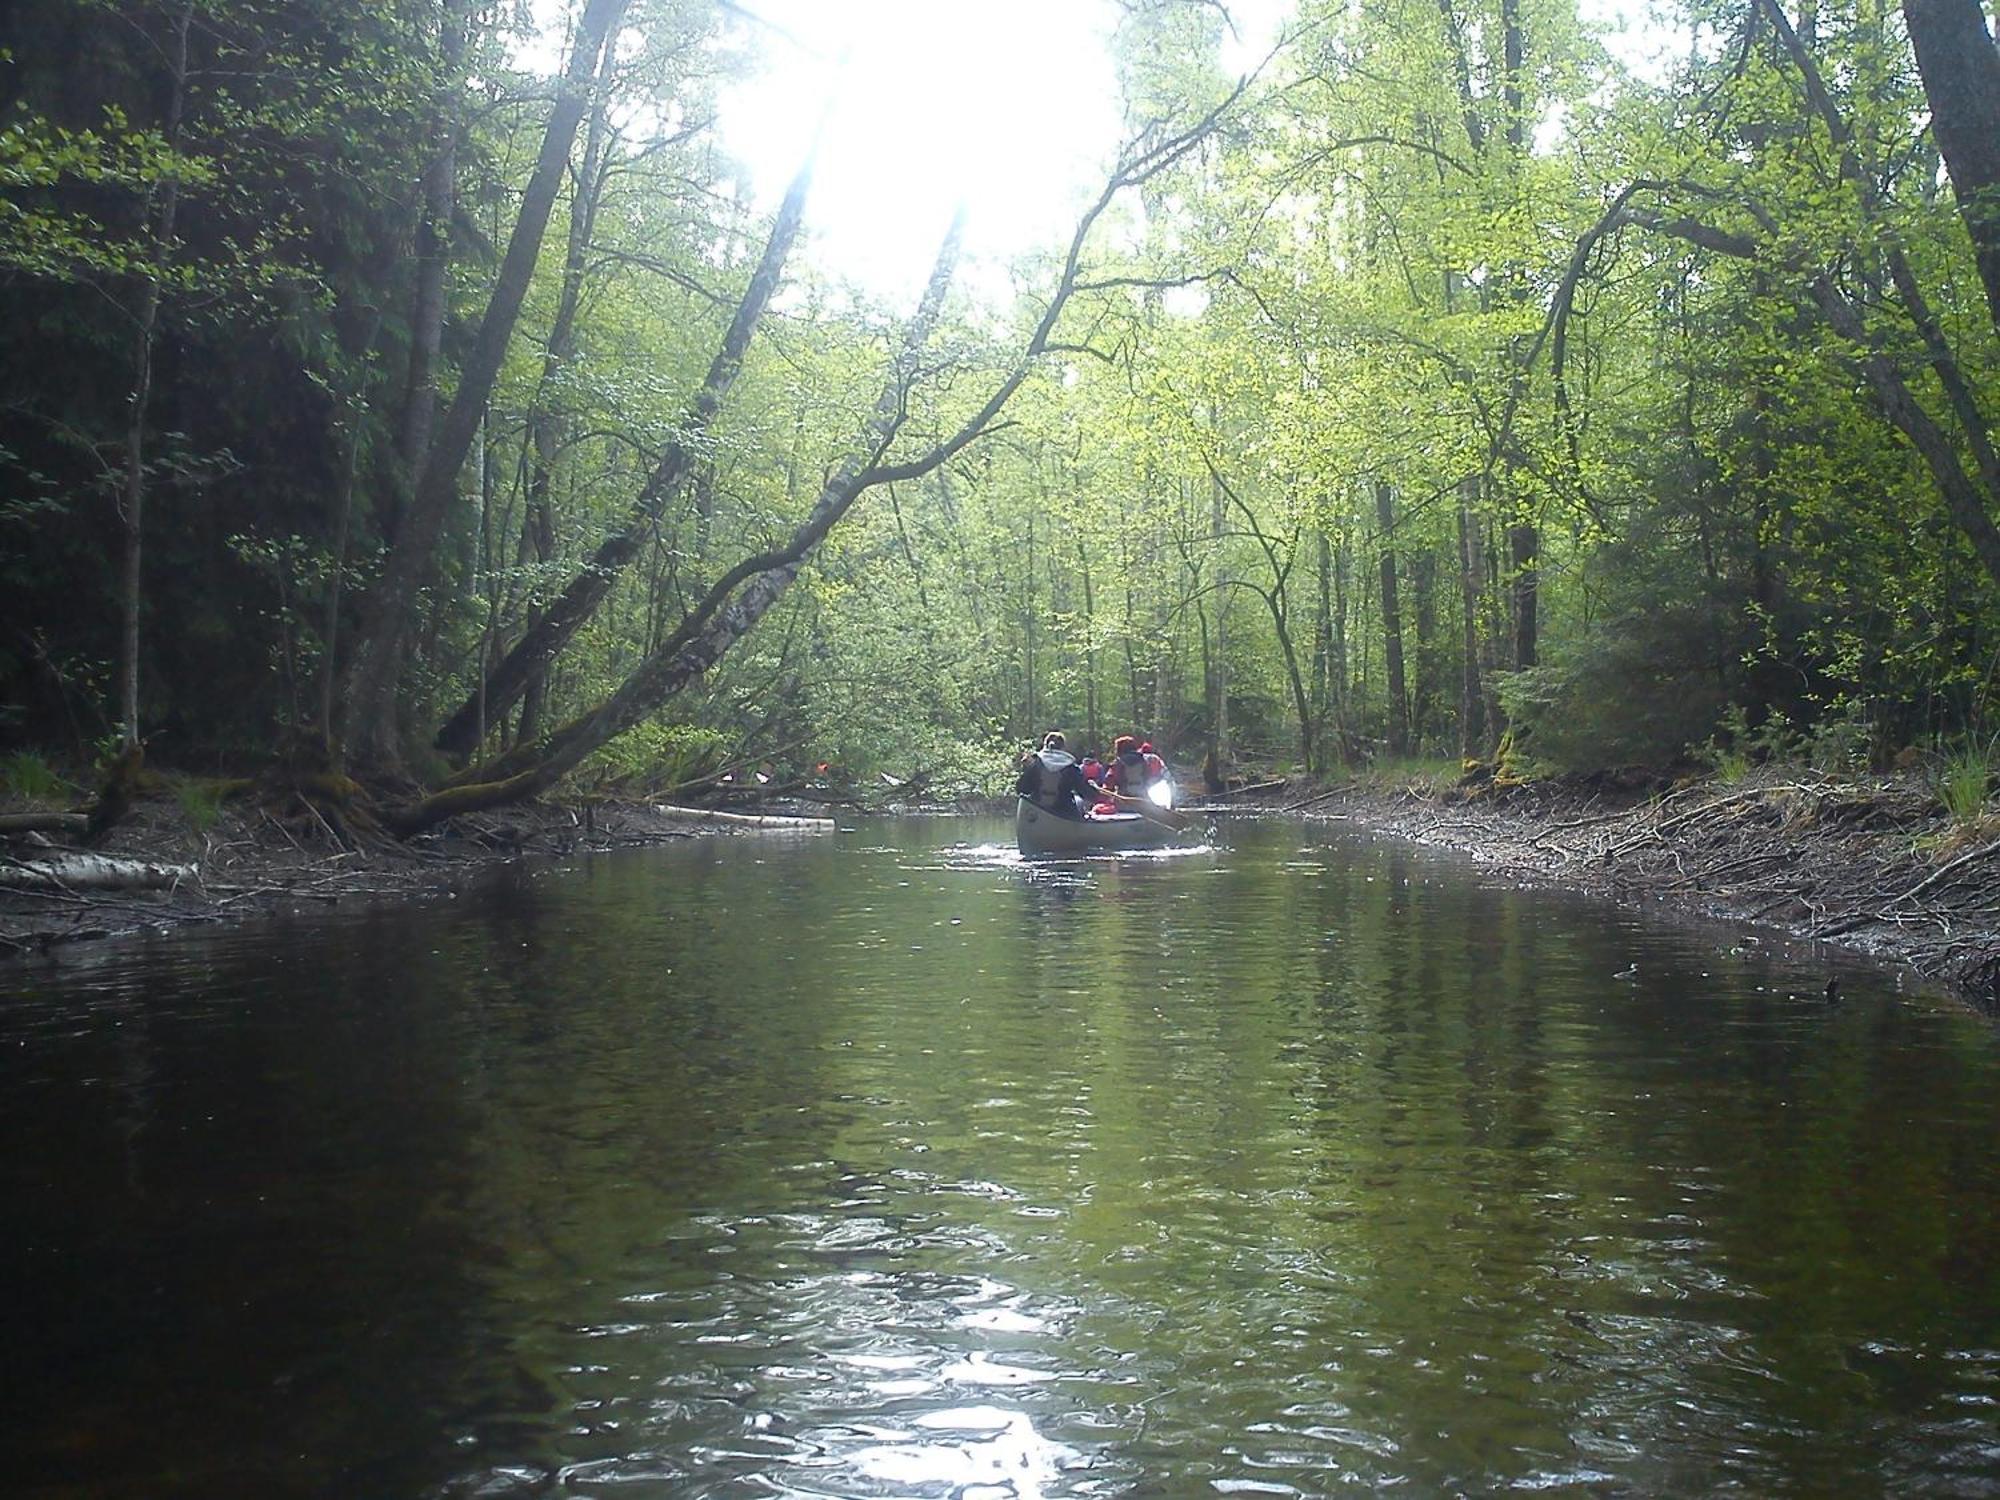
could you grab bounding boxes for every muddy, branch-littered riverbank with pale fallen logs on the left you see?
[0,794,824,962]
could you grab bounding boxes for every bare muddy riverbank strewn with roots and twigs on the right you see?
[1198,766,2000,1012]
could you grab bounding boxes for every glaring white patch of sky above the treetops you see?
[718,0,1292,302]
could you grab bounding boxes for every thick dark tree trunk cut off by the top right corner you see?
[1902,0,2000,328]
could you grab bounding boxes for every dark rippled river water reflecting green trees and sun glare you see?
[0,822,2000,1498]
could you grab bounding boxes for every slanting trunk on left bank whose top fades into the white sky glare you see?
[436,151,812,754]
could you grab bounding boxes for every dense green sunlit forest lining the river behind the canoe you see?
[0,0,2000,832]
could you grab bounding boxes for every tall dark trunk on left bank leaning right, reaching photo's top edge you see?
[346,0,626,766]
